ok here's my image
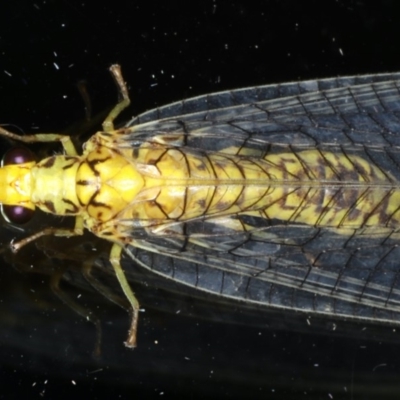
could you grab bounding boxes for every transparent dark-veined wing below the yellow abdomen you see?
[120,216,400,322]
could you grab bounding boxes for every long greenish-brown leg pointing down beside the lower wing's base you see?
[110,244,139,348]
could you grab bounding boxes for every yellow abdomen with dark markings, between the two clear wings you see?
[126,147,400,228]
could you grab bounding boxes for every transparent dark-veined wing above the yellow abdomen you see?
[124,73,400,154]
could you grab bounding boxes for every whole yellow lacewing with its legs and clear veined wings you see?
[0,66,400,346]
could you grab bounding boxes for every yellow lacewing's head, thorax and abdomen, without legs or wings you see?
[8,138,394,241]
